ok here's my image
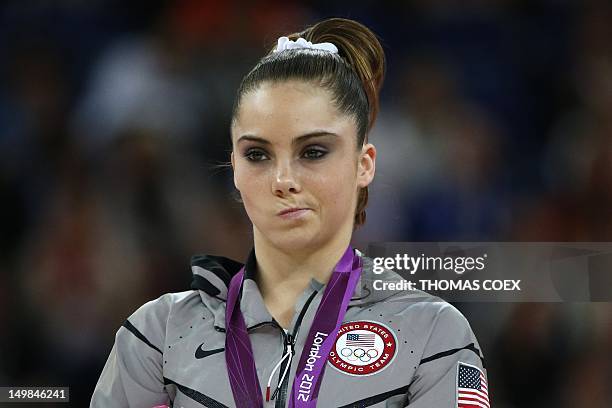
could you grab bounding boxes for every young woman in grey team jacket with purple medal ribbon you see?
[91,18,489,408]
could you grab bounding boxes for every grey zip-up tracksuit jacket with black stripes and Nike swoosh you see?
[90,251,488,408]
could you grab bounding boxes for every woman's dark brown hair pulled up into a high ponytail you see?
[232,18,385,226]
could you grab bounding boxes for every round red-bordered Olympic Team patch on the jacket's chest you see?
[328,320,397,376]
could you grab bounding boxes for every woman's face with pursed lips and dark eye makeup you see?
[232,81,376,251]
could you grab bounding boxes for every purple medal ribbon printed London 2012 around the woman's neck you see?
[225,245,361,408]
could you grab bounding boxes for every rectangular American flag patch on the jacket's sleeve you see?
[457,362,490,408]
